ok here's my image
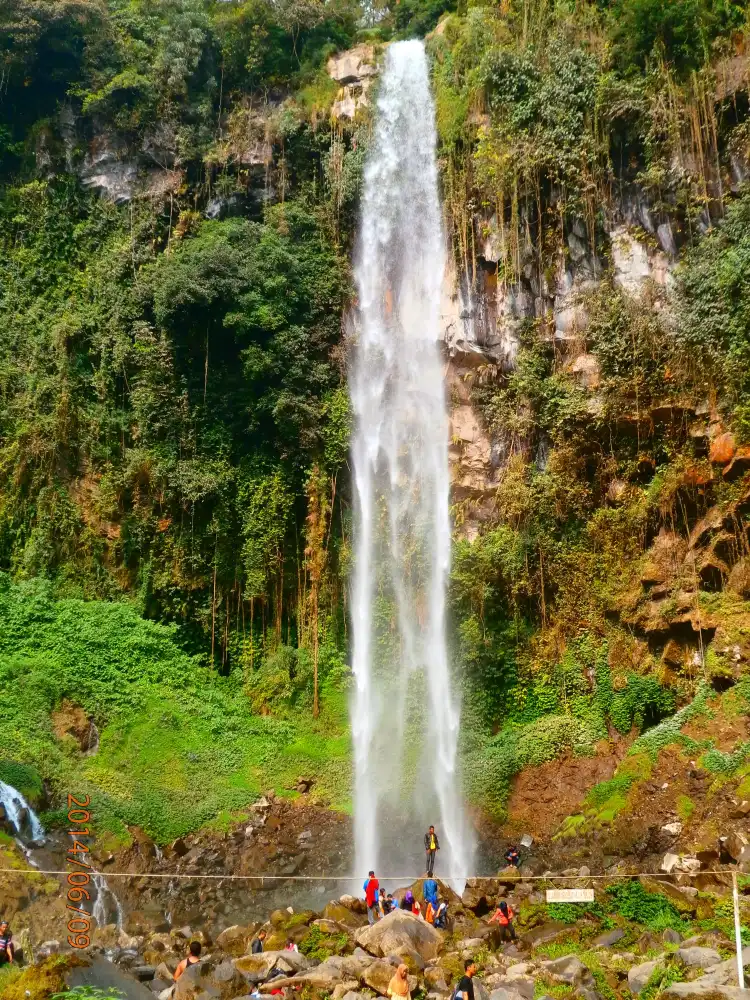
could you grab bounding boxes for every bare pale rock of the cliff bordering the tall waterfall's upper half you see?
[328,45,677,540]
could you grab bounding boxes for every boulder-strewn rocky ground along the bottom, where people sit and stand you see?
[11,870,750,1000]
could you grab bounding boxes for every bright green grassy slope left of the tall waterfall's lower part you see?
[0,582,349,842]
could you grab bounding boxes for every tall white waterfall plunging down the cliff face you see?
[350,41,473,883]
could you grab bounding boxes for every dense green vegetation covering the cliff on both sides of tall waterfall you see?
[0,0,750,840]
